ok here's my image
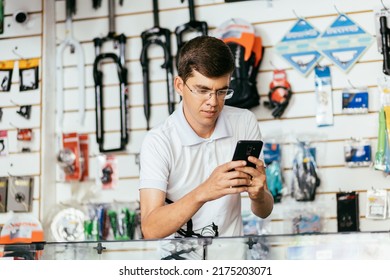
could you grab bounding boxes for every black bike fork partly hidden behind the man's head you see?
[175,0,208,67]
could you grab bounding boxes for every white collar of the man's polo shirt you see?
[173,102,232,146]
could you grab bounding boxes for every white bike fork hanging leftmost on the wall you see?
[56,0,85,132]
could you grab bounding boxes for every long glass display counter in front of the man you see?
[0,232,390,260]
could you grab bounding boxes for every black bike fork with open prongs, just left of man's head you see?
[140,0,175,130]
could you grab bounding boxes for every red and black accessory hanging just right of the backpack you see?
[264,70,292,118]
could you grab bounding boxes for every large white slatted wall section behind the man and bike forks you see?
[46,0,388,238]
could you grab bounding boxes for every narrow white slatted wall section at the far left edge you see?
[0,1,43,224]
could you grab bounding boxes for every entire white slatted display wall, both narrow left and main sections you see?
[0,0,390,241]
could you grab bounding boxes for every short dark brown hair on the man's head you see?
[177,36,234,81]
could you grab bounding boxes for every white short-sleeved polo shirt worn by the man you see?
[139,103,261,237]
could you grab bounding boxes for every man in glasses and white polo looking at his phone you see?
[140,36,273,241]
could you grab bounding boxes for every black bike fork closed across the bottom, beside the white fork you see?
[93,0,129,153]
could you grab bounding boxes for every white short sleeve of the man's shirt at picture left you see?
[139,132,169,192]
